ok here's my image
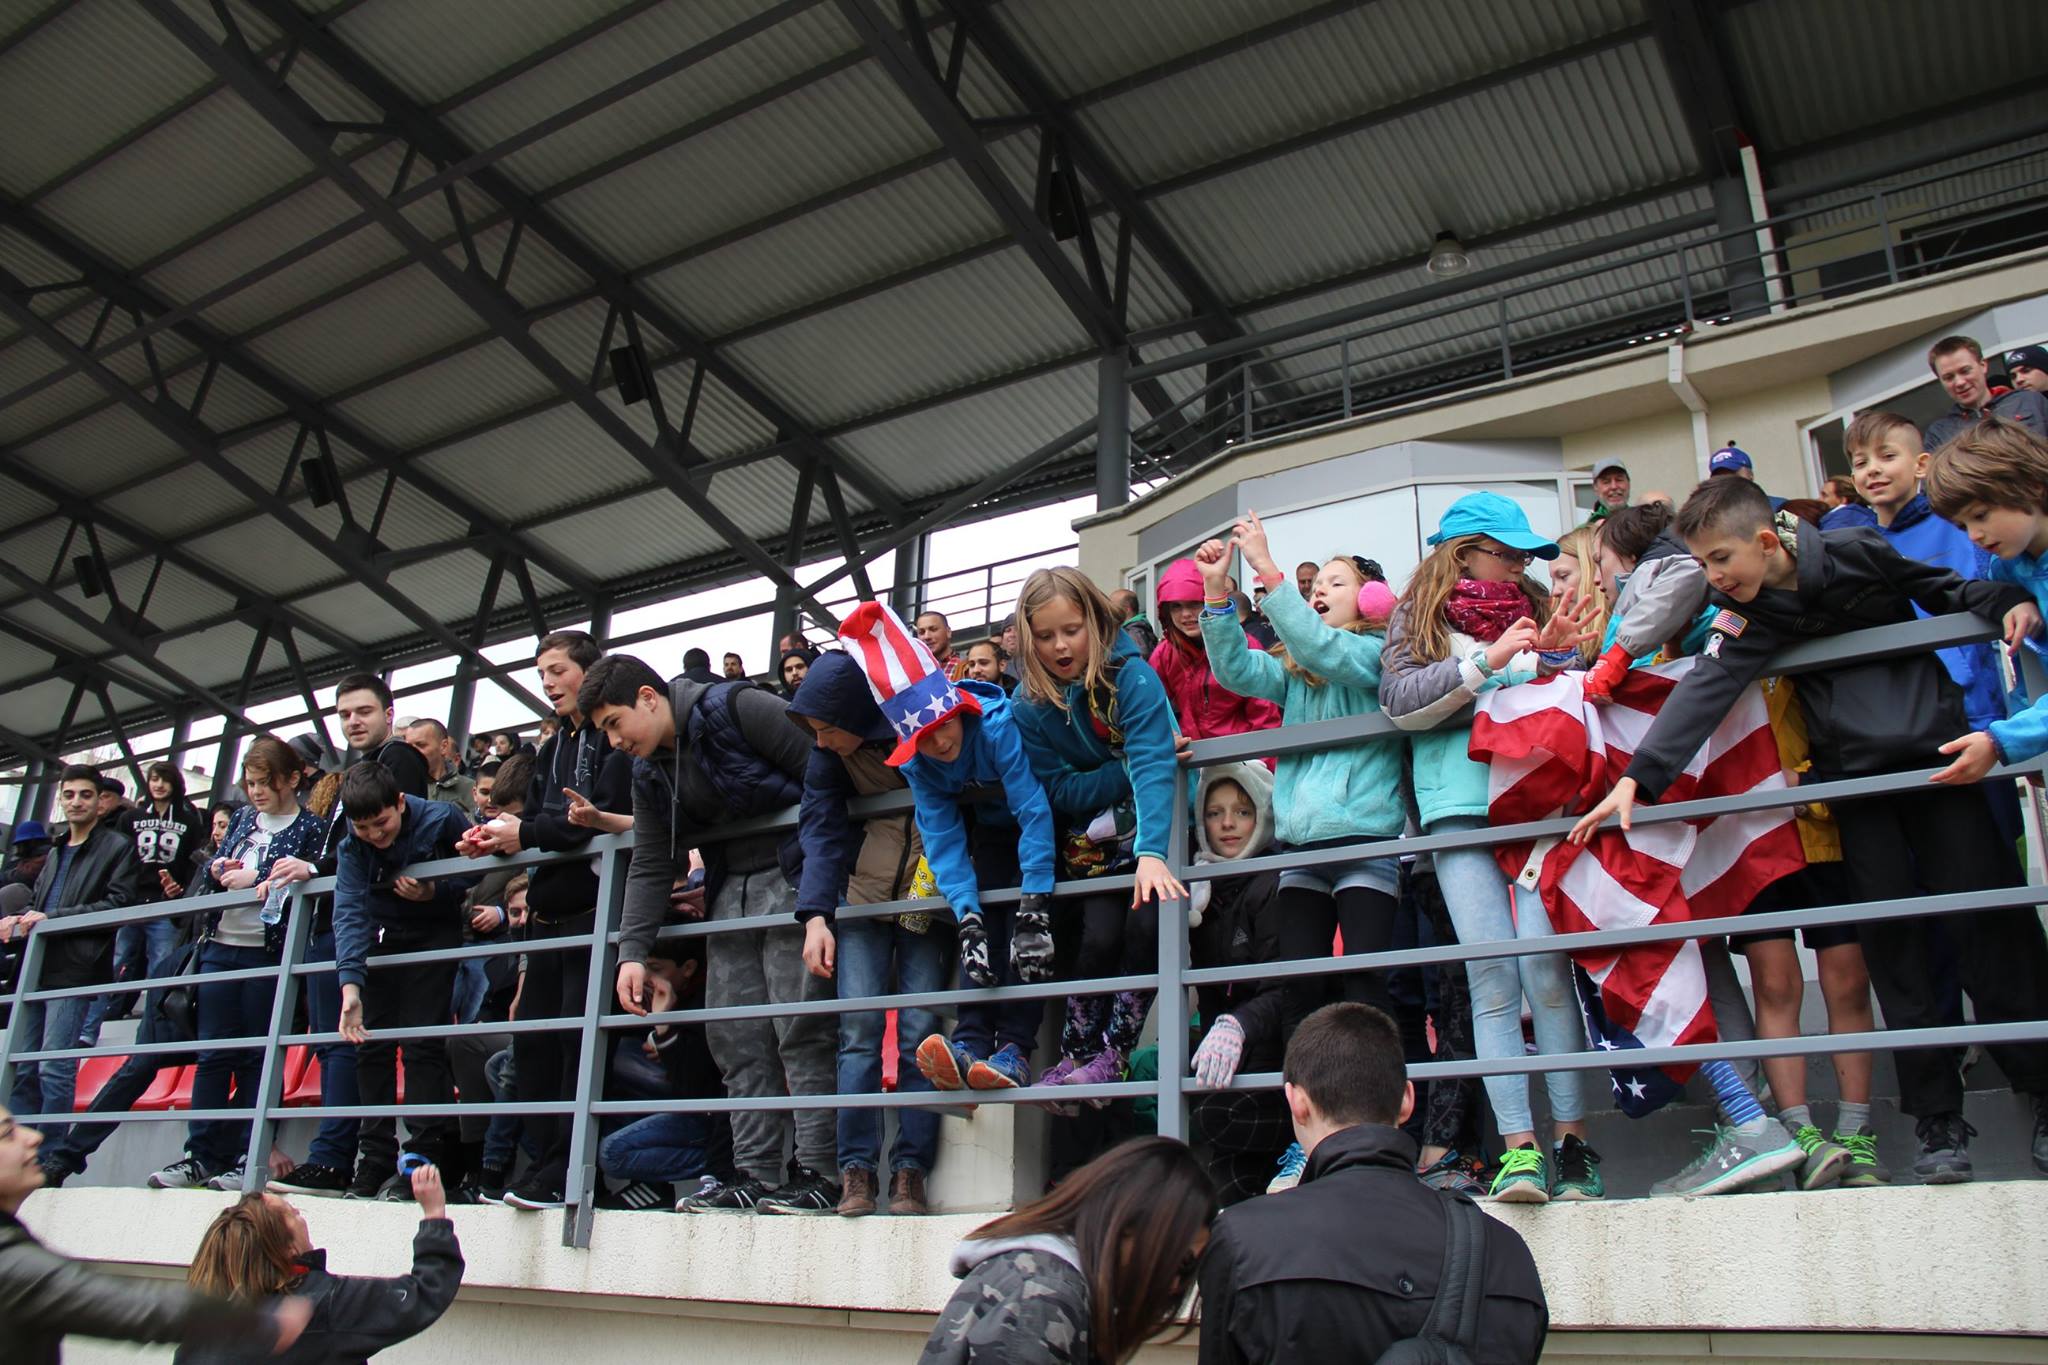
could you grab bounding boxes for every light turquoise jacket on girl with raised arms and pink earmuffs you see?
[1202,587,1407,843]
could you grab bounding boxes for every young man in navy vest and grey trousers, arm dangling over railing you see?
[578,655,840,1214]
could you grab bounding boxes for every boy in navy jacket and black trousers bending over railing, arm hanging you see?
[334,763,477,1199]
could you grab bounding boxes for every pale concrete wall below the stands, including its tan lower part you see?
[23,1181,2048,1363]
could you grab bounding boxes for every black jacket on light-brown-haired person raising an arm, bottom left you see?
[176,1218,463,1365]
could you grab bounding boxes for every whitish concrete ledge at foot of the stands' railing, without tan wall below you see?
[23,1181,2048,1359]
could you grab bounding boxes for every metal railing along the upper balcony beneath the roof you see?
[1124,147,2048,469]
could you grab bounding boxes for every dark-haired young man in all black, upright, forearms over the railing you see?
[463,630,633,1209]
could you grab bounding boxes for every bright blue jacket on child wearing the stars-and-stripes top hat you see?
[903,679,1053,915]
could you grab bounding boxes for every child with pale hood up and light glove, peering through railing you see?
[1188,763,1294,1205]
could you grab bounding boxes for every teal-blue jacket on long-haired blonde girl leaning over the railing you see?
[1012,630,1180,860]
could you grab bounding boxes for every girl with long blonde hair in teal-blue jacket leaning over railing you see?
[1016,569,1187,1105]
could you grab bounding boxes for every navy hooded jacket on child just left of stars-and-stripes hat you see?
[788,651,909,921]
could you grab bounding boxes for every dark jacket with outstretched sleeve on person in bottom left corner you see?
[0,1214,276,1365]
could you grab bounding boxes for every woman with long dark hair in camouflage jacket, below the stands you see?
[918,1138,1217,1365]
